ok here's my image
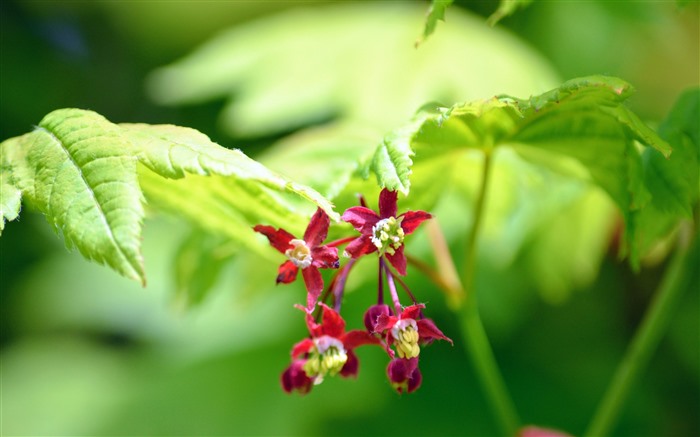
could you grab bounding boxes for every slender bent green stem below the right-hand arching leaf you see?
[459,149,520,435]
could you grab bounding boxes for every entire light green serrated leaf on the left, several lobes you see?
[0,109,338,283]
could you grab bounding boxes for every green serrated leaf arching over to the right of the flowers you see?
[371,76,682,263]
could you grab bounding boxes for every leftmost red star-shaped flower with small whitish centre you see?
[253,208,340,310]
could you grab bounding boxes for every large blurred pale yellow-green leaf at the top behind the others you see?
[147,2,559,137]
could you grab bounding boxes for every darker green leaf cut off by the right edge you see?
[637,89,700,253]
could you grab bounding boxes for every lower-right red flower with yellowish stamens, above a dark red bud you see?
[374,304,452,359]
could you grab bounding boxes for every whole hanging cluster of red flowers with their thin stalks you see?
[253,189,452,394]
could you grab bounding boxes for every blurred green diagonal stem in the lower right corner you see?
[585,227,700,437]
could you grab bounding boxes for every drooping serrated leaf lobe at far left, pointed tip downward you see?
[0,109,145,283]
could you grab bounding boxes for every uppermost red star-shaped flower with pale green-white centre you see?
[341,188,432,275]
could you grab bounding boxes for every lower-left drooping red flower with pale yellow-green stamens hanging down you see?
[282,303,379,392]
